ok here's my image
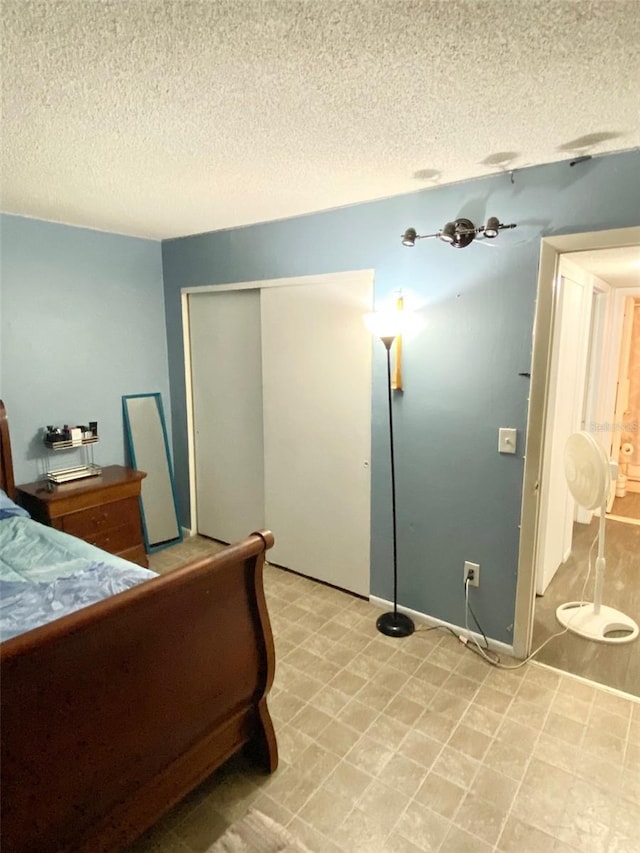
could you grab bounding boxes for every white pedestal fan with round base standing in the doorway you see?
[556,432,638,643]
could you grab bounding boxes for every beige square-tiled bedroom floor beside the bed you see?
[130,540,640,853]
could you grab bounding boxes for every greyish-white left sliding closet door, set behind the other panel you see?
[189,290,265,542]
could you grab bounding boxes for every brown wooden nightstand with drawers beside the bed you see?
[16,465,148,568]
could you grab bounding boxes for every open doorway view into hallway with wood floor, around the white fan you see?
[516,235,640,695]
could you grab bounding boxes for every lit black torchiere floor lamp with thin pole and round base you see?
[365,311,415,637]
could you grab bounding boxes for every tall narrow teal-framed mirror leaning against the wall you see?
[122,392,183,553]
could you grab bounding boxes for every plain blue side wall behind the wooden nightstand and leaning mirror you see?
[0,215,169,483]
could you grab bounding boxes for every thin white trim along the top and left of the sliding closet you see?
[180,269,375,536]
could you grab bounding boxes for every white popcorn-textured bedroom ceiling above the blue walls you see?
[2,0,640,238]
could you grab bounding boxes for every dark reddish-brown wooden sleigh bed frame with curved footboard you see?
[0,401,278,853]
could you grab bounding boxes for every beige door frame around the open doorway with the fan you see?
[513,226,640,658]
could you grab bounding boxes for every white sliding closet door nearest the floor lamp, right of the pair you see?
[261,274,373,595]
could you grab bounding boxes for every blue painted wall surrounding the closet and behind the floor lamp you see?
[162,151,640,643]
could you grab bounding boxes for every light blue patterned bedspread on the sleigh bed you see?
[0,518,156,641]
